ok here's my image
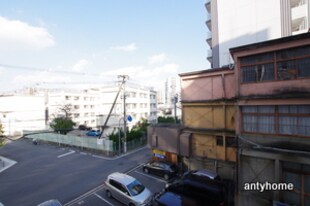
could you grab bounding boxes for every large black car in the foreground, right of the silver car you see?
[165,170,227,205]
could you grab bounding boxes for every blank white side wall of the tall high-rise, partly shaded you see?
[216,0,281,67]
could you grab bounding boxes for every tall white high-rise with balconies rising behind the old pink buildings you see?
[205,0,310,68]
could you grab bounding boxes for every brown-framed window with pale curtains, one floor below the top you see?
[241,105,310,136]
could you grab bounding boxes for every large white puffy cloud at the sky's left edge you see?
[0,16,55,50]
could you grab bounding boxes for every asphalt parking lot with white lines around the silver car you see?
[65,165,167,206]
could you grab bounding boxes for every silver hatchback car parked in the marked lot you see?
[105,172,152,206]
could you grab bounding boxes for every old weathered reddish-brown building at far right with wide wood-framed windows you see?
[230,33,310,206]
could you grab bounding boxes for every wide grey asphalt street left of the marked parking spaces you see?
[0,139,155,206]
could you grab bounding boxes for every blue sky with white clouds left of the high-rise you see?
[0,0,210,94]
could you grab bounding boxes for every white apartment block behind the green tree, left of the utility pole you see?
[47,89,100,127]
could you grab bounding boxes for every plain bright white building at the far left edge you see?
[0,95,46,136]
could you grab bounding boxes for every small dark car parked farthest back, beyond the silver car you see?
[143,161,178,180]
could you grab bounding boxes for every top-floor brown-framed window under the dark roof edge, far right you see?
[240,46,310,83]
